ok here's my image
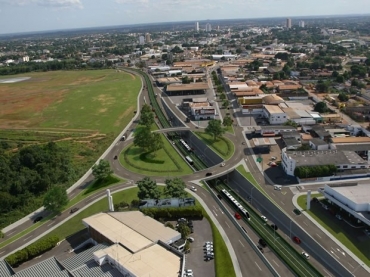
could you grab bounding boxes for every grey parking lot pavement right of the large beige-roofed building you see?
[186,219,217,277]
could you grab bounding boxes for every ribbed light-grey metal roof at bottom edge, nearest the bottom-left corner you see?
[13,257,70,277]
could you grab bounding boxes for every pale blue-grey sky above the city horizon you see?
[0,0,370,34]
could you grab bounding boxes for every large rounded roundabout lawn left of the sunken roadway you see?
[119,135,193,176]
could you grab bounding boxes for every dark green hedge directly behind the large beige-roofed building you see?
[140,206,203,219]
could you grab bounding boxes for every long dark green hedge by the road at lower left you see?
[5,236,59,267]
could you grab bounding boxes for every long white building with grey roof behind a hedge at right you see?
[281,148,369,176]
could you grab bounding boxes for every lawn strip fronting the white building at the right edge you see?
[297,194,370,266]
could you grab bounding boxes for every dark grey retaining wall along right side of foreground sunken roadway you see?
[225,170,353,277]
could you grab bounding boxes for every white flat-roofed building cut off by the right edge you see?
[320,184,370,226]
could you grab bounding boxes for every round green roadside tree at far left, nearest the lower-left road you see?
[43,185,69,212]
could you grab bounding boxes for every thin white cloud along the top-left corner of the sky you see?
[0,0,83,8]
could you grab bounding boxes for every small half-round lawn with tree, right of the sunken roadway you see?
[194,132,235,160]
